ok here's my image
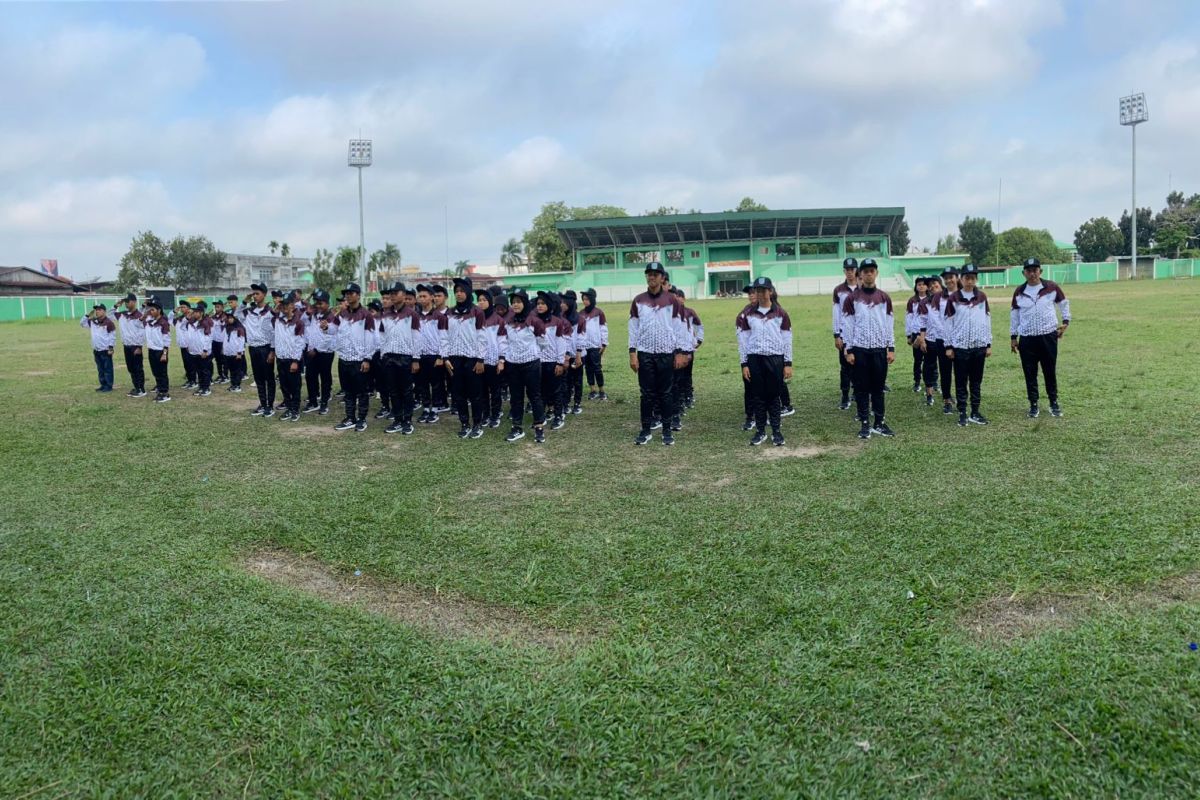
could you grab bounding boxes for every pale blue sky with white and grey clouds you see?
[0,0,1200,279]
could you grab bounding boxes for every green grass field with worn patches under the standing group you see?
[0,281,1200,798]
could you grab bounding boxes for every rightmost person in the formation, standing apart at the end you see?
[1008,258,1070,419]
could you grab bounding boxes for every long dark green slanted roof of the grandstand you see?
[556,206,904,249]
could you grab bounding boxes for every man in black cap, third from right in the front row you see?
[841,258,896,439]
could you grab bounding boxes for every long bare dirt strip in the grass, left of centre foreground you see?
[244,551,586,648]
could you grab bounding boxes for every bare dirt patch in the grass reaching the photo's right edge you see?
[960,572,1200,644]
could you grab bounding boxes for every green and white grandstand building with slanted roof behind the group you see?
[504,207,945,301]
